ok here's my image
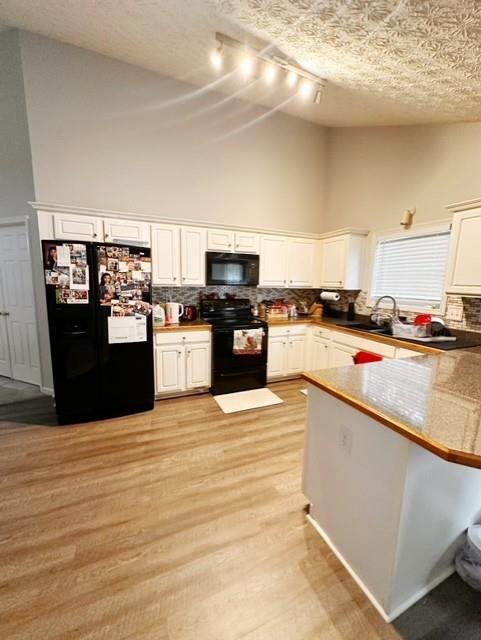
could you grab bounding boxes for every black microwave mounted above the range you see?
[205,251,259,287]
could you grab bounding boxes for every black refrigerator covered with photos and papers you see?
[42,240,154,424]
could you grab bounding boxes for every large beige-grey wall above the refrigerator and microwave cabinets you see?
[21,33,326,232]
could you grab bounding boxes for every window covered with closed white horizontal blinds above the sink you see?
[371,230,450,309]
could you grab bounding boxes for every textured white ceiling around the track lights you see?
[0,0,481,126]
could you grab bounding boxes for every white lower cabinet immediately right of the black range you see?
[267,325,306,379]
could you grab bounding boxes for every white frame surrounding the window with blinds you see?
[367,220,451,315]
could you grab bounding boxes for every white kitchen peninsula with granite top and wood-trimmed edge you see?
[303,350,481,621]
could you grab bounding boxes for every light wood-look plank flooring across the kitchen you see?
[0,381,398,640]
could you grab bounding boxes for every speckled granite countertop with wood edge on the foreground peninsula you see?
[302,349,481,468]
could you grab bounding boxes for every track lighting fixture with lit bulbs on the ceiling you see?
[210,33,326,104]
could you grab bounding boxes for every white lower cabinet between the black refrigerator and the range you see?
[155,331,211,395]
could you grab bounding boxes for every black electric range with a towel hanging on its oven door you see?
[200,298,268,395]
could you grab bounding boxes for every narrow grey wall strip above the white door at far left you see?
[0,30,34,218]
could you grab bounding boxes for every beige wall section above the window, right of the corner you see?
[323,123,481,231]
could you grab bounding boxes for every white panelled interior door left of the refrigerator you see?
[0,225,40,384]
